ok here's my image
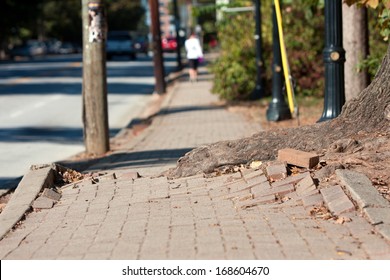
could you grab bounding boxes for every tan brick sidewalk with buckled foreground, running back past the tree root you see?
[0,61,390,260]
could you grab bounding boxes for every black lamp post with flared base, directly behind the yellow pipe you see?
[267,2,291,121]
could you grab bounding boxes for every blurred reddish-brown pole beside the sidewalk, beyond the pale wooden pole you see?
[149,0,166,94]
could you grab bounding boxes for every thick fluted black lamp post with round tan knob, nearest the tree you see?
[319,0,345,122]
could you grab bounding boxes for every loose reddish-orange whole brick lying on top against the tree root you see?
[278,149,320,169]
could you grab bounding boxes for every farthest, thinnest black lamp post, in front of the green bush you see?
[251,0,264,99]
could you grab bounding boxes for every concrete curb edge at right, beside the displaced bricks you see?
[336,169,390,241]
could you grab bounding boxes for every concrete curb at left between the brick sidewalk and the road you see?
[0,164,62,240]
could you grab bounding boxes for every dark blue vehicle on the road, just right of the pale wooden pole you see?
[106,31,137,59]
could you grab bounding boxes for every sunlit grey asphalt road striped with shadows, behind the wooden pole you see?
[0,52,176,189]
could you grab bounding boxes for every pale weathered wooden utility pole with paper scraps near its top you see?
[82,0,110,155]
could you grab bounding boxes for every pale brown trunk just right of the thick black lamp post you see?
[343,3,368,101]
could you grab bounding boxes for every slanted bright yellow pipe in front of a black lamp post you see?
[274,0,295,114]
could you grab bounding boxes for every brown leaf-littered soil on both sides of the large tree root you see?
[228,99,390,202]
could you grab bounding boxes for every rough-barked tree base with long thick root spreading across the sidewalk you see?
[166,45,390,178]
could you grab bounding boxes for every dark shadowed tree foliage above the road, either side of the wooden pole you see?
[0,0,145,48]
